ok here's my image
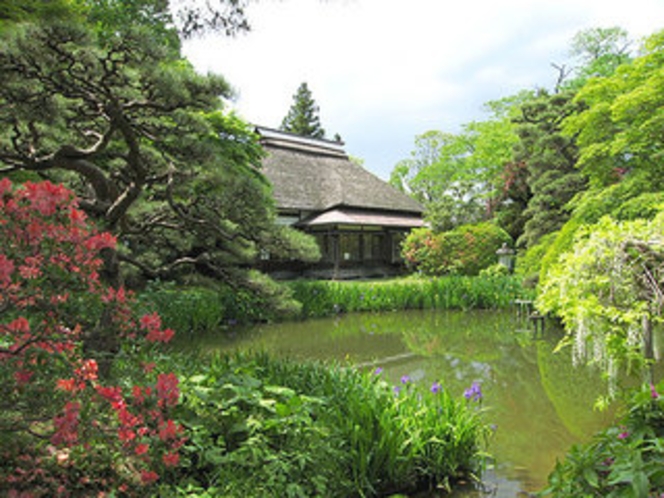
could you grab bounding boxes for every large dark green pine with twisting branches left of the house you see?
[0,7,317,298]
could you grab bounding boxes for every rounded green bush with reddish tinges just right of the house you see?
[403,223,512,276]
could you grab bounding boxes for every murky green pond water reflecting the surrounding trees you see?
[182,311,613,497]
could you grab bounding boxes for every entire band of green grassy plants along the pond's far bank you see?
[139,275,534,336]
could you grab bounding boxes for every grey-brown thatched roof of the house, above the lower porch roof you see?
[256,127,423,216]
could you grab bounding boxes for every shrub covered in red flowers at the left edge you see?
[0,178,184,496]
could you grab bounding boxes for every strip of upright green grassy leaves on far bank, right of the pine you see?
[289,275,524,318]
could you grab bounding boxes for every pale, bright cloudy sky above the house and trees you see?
[184,0,664,179]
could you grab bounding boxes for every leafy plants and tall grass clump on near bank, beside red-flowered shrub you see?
[163,354,488,497]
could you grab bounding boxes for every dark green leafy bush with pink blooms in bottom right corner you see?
[543,383,664,498]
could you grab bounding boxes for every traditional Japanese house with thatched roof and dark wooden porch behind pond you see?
[256,127,423,279]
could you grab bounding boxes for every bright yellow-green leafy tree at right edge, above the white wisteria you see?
[541,33,664,286]
